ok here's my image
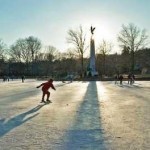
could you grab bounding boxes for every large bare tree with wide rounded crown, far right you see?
[118,23,148,71]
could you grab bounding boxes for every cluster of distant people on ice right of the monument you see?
[115,73,135,85]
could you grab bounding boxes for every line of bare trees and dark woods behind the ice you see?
[0,23,150,78]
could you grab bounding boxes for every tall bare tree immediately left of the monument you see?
[67,26,87,73]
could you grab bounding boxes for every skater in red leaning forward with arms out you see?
[36,79,56,103]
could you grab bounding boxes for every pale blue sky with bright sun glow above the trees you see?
[0,0,150,52]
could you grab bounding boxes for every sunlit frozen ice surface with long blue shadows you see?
[0,80,150,150]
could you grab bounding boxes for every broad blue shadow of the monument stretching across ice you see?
[60,81,107,150]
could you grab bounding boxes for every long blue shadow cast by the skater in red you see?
[0,105,44,137]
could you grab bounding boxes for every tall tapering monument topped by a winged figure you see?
[88,26,98,76]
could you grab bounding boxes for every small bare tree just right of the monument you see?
[98,40,112,74]
